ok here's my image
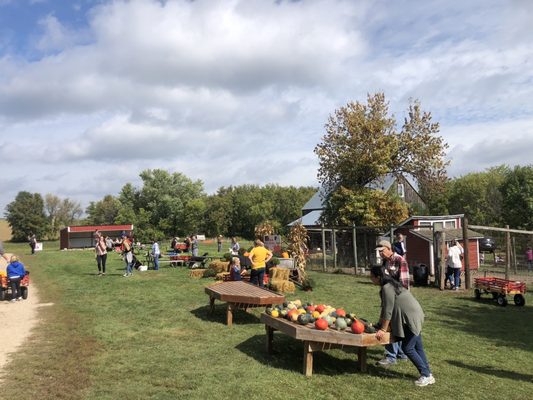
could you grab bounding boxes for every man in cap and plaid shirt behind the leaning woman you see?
[376,240,409,367]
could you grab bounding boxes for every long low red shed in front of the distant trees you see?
[59,224,133,250]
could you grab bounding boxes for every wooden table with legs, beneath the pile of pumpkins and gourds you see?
[261,314,390,376]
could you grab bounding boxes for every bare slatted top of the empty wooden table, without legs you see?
[205,281,285,305]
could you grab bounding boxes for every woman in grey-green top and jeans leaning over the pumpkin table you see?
[370,267,435,386]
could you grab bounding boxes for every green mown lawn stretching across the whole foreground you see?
[0,243,533,400]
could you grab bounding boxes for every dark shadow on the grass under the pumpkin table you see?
[235,334,405,378]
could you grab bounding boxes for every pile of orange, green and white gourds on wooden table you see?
[265,300,376,334]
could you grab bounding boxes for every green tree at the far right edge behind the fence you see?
[501,164,533,230]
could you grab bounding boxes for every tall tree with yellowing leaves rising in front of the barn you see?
[315,93,448,222]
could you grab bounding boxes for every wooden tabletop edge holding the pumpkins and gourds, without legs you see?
[261,313,390,347]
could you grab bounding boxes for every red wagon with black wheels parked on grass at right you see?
[474,277,526,307]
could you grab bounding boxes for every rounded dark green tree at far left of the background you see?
[5,192,48,242]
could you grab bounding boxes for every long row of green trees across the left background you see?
[6,169,316,241]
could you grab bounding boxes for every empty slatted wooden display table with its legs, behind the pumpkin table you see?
[205,281,285,326]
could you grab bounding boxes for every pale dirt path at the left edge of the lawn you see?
[0,283,49,382]
